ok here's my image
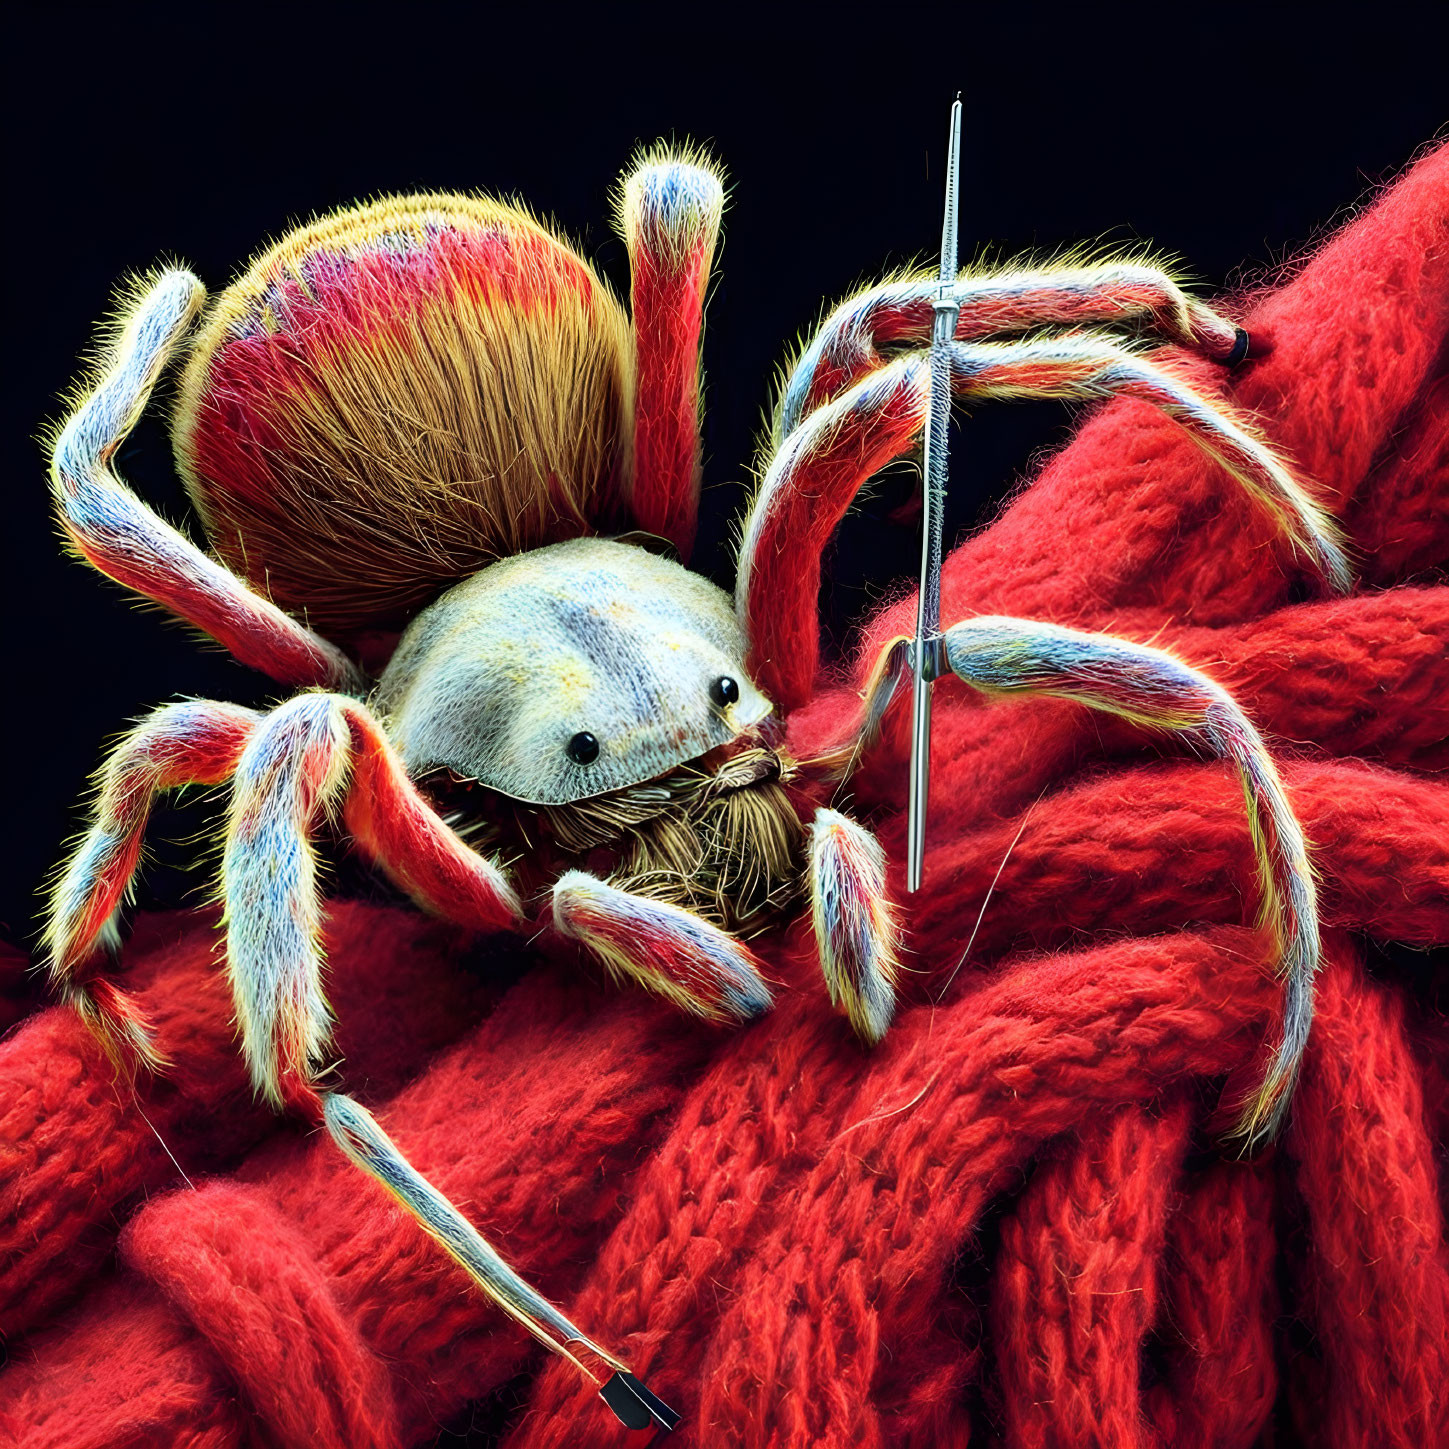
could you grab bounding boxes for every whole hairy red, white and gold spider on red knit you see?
[46,149,1349,1426]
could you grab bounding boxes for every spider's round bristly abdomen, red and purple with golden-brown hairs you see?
[175,194,633,638]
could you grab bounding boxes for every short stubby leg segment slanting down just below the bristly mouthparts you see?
[554,871,772,1022]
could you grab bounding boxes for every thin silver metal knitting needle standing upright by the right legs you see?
[906,93,961,891]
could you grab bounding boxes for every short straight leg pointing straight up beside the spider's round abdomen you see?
[619,148,725,558]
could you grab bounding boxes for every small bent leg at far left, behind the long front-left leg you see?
[43,700,261,1066]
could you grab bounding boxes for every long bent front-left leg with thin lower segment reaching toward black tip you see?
[205,694,634,1391]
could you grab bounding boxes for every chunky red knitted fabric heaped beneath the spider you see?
[0,141,1449,1449]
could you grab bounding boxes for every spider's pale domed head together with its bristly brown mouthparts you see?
[385,539,804,933]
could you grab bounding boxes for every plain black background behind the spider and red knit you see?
[0,4,1449,945]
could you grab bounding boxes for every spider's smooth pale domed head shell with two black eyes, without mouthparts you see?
[377,539,771,806]
